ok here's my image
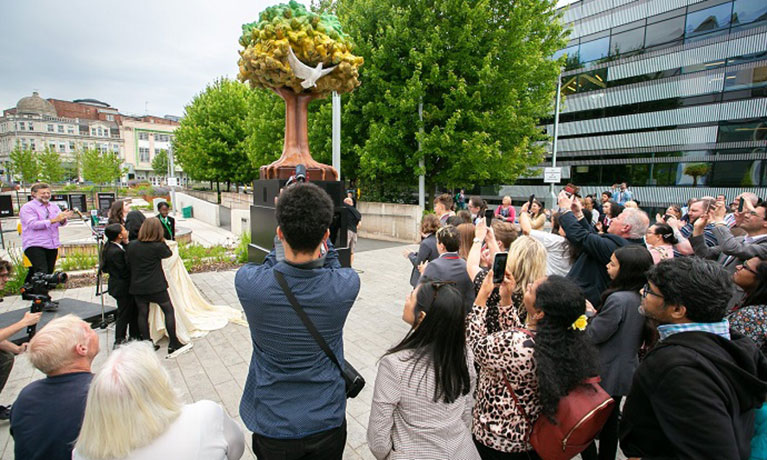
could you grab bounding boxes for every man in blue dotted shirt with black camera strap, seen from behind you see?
[234,183,360,460]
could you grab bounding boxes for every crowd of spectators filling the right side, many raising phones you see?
[392,188,767,460]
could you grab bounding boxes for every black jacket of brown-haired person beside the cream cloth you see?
[125,241,173,295]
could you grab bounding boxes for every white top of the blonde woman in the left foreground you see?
[72,400,245,460]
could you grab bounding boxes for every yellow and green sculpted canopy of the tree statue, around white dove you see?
[238,0,363,95]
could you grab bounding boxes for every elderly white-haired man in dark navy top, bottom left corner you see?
[11,315,99,460]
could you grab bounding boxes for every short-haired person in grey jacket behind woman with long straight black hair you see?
[421,225,474,313]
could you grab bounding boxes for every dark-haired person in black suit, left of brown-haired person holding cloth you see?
[101,224,141,346]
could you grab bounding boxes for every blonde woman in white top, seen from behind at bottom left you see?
[72,342,245,460]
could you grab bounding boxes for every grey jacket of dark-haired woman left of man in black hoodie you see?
[586,291,645,396]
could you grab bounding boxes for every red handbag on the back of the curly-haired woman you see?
[503,329,615,460]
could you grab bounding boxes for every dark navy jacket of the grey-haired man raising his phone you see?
[559,212,643,305]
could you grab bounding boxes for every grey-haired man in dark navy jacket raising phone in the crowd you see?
[558,191,650,306]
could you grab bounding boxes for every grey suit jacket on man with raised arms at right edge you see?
[690,225,767,273]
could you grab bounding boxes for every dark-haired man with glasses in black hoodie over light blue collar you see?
[620,257,767,459]
